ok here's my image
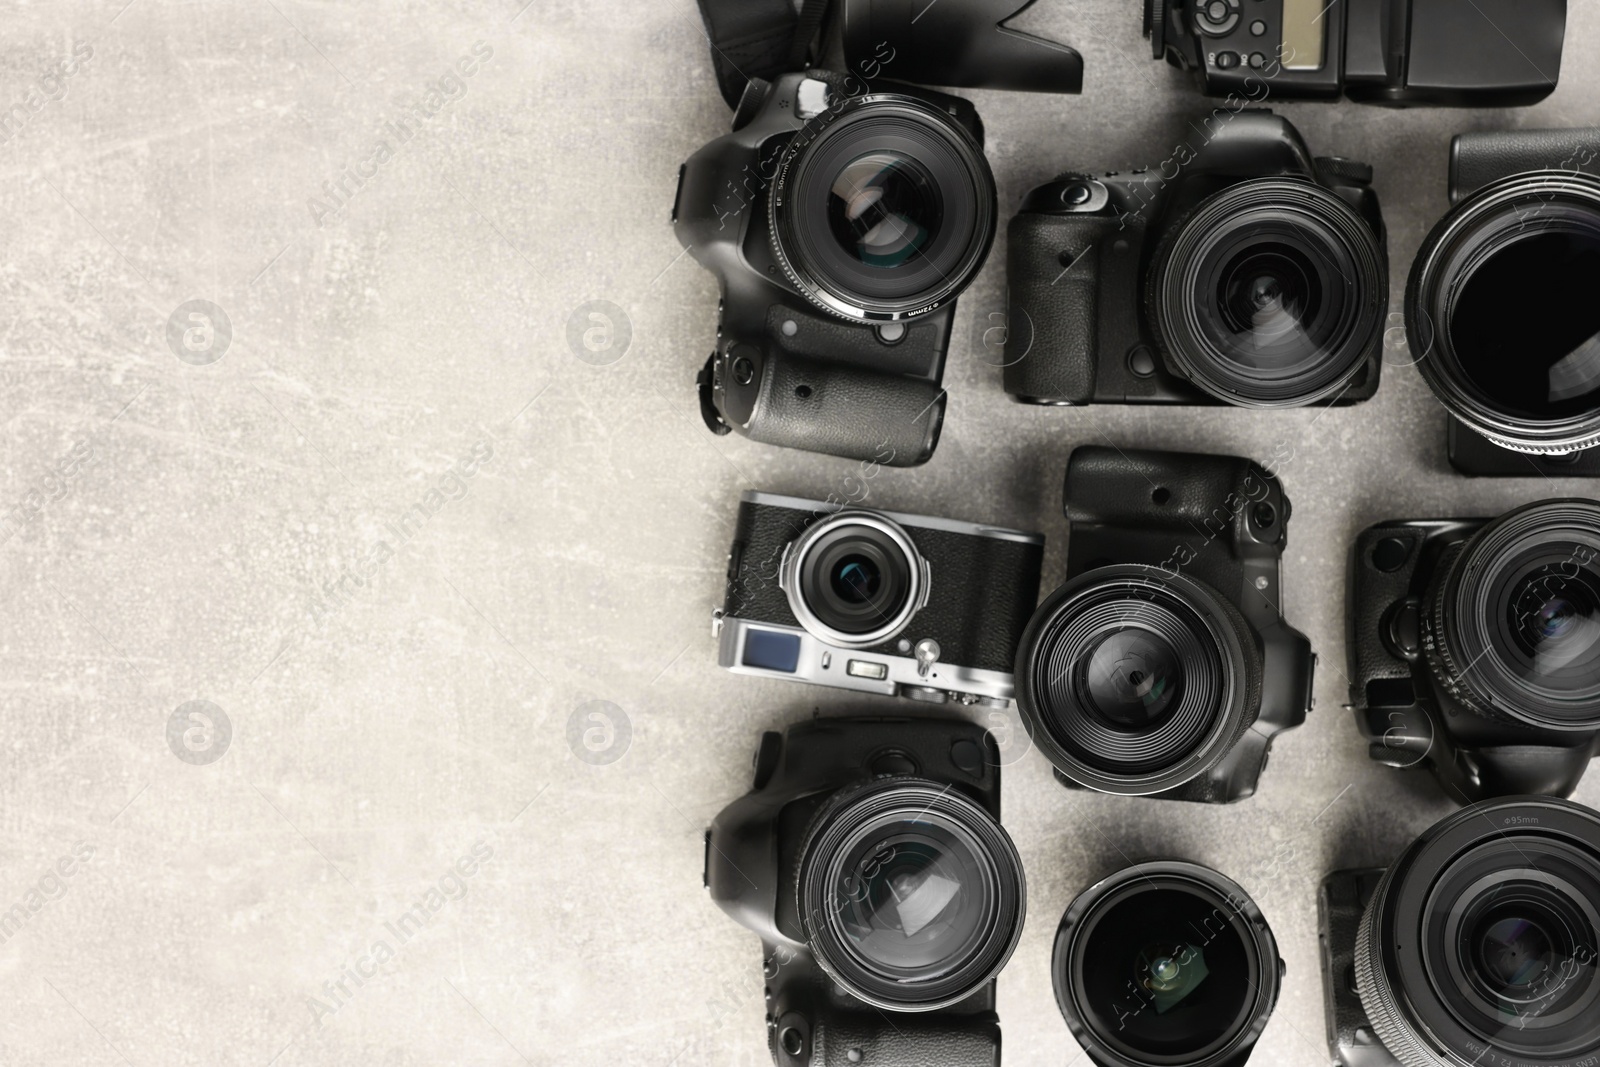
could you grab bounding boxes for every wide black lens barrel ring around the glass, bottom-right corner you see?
[1355,797,1600,1067]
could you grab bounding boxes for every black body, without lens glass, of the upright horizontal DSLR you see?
[1003,110,1389,406]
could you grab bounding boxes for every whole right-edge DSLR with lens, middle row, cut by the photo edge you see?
[1349,499,1600,801]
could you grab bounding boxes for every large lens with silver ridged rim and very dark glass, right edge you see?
[1406,173,1600,453]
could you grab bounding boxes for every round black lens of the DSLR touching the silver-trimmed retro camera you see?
[1016,565,1262,795]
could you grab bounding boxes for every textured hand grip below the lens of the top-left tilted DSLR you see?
[749,354,944,467]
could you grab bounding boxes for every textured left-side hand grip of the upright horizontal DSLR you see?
[1003,213,1117,403]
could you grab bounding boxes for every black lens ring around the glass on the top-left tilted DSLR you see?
[766,93,998,323]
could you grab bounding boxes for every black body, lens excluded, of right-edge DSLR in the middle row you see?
[1349,518,1600,801]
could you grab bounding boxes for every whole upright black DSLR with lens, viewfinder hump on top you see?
[1003,110,1389,408]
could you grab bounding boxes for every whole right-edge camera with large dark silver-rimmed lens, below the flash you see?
[1405,130,1600,478]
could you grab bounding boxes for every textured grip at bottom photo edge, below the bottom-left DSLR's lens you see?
[811,1014,1000,1067]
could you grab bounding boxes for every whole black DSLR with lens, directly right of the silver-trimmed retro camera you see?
[1016,446,1315,803]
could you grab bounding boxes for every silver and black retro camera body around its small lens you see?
[714,493,1045,707]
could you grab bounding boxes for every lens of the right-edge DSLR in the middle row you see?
[1426,501,1600,729]
